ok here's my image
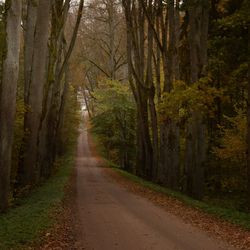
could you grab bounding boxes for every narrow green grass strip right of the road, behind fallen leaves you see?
[110,164,250,230]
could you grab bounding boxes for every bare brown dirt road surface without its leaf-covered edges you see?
[75,125,236,250]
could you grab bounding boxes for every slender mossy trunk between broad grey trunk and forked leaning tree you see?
[38,0,70,178]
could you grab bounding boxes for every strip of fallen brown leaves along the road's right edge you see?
[105,168,250,250]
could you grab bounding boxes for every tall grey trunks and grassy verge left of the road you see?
[0,0,83,244]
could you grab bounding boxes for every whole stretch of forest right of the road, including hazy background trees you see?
[82,0,250,211]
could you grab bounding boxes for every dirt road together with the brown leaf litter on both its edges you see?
[39,123,250,250]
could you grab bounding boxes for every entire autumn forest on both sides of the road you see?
[0,0,250,230]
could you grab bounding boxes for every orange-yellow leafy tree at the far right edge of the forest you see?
[213,109,247,193]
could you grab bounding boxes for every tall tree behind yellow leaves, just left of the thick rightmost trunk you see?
[141,0,180,189]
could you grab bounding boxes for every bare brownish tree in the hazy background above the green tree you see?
[80,0,126,80]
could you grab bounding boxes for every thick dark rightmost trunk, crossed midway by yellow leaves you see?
[185,0,209,199]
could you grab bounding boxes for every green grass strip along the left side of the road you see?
[0,154,74,250]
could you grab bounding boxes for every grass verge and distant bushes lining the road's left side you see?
[0,82,81,249]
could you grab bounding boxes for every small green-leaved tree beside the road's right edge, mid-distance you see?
[91,80,136,171]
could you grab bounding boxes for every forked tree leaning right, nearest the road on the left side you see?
[43,0,84,176]
